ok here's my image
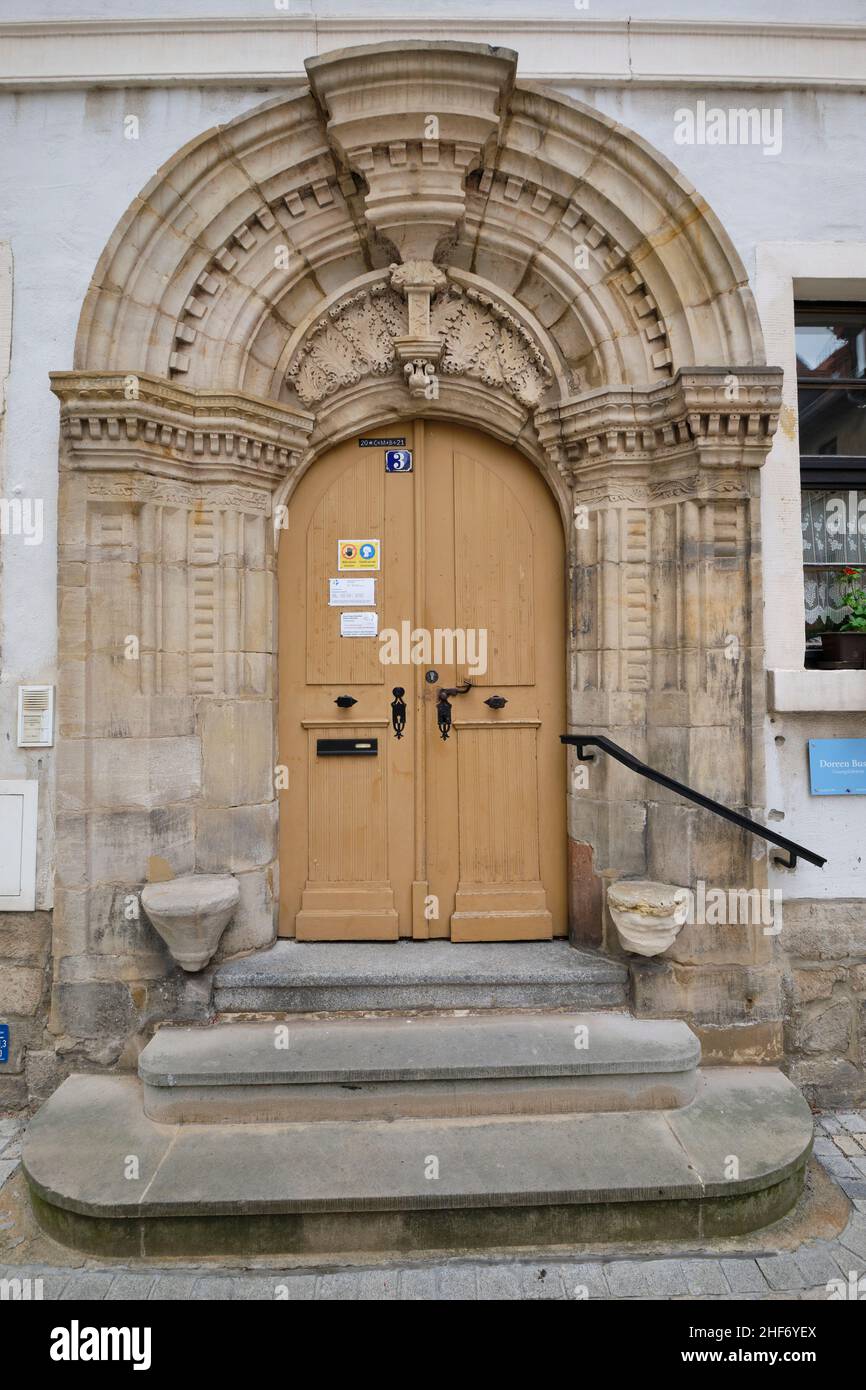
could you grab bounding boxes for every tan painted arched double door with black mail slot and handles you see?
[278,423,567,941]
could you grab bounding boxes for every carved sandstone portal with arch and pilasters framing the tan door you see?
[51,43,781,1055]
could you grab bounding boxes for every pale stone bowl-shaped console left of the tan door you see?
[142,873,240,972]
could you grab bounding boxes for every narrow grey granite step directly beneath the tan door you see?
[214,941,628,1013]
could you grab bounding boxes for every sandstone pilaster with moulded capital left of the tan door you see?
[47,373,311,1056]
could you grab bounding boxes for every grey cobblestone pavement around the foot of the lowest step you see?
[0,1109,866,1301]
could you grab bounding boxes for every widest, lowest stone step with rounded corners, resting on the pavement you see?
[22,1068,812,1258]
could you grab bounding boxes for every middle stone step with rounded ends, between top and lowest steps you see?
[139,1012,701,1123]
